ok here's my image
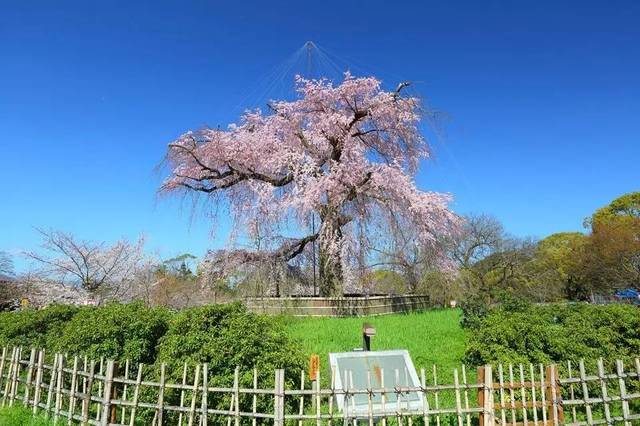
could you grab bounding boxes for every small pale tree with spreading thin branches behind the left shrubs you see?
[26,229,144,299]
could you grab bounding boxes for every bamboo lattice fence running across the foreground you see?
[0,348,640,426]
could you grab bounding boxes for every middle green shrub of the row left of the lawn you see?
[52,303,171,365]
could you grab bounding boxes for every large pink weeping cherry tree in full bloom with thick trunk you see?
[162,74,459,296]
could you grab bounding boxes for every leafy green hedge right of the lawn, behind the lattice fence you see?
[464,304,640,365]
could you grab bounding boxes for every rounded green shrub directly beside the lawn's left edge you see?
[156,304,305,422]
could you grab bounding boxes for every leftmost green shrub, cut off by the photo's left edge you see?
[0,305,83,348]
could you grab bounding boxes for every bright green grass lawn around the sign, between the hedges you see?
[282,309,466,379]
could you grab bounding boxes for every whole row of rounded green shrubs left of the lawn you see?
[0,303,304,383]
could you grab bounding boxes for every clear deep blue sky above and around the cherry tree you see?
[0,1,640,270]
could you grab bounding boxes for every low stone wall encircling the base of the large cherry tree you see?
[244,295,431,317]
